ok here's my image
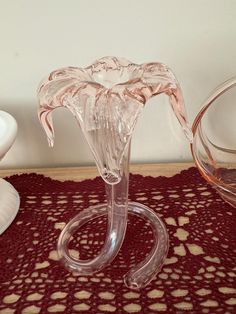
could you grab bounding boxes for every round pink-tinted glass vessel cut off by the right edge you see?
[191,77,236,207]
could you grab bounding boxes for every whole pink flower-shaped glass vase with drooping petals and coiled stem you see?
[38,57,191,288]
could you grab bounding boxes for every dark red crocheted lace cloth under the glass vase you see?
[0,168,236,314]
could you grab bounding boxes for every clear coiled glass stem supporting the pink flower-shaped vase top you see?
[58,147,168,289]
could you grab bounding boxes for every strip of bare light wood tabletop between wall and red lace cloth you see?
[0,163,194,181]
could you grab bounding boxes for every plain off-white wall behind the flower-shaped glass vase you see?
[0,0,236,168]
